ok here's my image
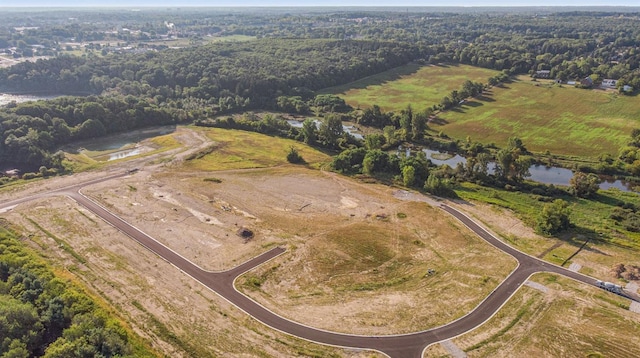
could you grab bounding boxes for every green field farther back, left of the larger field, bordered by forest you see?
[322,64,498,112]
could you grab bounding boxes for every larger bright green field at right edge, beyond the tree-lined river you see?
[431,76,640,158]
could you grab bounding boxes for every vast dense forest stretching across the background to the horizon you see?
[0,8,640,174]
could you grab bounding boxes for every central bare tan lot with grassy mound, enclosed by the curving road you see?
[85,161,515,334]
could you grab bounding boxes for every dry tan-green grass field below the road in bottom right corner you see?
[425,274,640,357]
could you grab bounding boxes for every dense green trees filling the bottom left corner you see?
[0,222,154,358]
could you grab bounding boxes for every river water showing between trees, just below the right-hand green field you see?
[420,149,634,191]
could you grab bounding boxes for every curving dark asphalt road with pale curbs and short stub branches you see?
[0,174,638,358]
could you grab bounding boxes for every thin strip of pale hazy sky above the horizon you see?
[0,0,640,7]
